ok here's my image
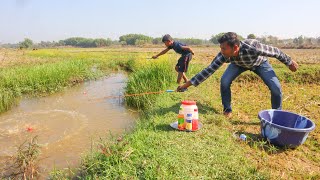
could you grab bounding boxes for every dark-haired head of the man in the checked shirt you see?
[218,32,240,58]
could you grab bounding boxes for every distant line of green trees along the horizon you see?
[0,33,320,48]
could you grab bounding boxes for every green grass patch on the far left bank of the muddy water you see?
[0,60,102,112]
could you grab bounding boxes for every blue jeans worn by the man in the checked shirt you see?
[220,61,282,112]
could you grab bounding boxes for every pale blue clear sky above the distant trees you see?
[0,0,320,43]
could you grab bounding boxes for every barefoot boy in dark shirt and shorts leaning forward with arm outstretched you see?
[152,34,194,84]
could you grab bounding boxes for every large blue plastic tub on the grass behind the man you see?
[258,109,315,148]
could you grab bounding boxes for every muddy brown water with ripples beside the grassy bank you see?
[0,74,137,172]
